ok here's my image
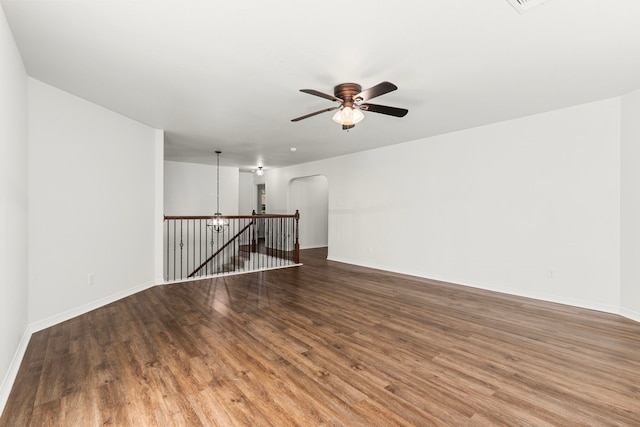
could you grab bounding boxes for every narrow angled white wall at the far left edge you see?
[0,5,28,414]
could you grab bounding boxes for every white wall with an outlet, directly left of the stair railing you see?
[29,79,162,329]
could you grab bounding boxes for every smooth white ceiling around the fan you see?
[1,0,640,170]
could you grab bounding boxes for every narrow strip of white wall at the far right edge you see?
[620,90,640,321]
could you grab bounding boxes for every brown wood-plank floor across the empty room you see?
[0,249,640,427]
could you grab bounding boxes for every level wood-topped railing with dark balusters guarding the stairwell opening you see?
[164,211,300,282]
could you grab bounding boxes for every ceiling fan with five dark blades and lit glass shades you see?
[291,82,409,130]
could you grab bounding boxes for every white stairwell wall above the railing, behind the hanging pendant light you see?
[164,161,239,216]
